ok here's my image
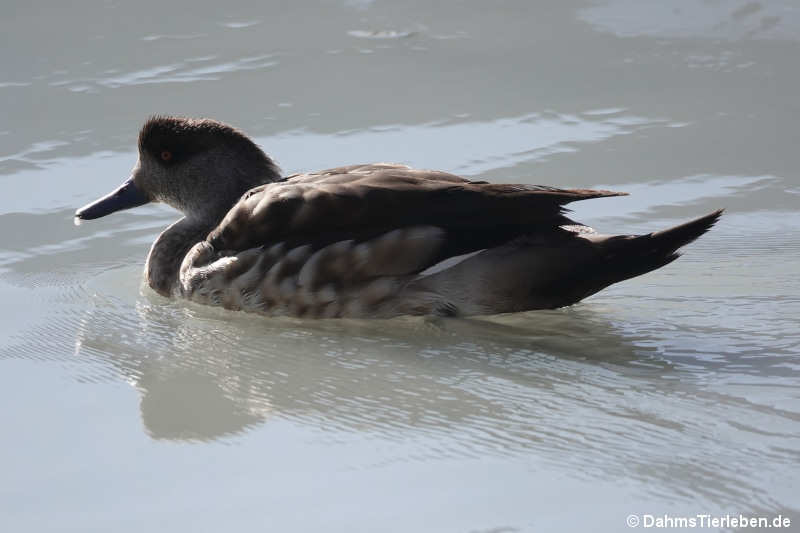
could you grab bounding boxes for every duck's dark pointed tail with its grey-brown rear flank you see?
[406,209,723,315]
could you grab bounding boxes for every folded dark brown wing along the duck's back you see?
[207,164,624,262]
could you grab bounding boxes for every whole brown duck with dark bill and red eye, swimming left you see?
[75,116,723,318]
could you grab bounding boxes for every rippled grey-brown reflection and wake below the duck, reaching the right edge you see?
[69,291,796,509]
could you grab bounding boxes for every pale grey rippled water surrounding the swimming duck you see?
[0,0,800,532]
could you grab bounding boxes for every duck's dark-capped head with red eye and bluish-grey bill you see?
[75,116,280,221]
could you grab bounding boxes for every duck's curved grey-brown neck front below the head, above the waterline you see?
[144,217,216,297]
